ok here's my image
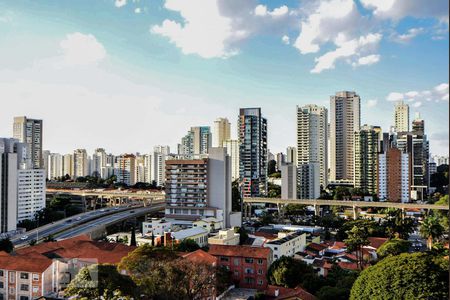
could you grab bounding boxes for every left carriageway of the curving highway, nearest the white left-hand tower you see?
[11,203,160,247]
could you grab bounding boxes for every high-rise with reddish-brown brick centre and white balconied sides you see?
[377,148,410,202]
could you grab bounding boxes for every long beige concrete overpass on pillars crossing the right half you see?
[243,198,449,218]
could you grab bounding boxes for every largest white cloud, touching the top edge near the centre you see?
[150,0,291,58]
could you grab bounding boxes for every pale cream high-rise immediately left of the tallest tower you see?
[297,104,328,189]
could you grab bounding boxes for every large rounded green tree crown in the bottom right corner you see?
[350,253,449,300]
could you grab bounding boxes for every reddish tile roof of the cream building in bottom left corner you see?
[0,253,52,273]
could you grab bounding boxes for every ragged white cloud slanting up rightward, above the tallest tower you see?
[311,33,382,73]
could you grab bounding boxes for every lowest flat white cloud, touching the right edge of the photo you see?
[386,82,449,107]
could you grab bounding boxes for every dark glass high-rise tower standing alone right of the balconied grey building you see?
[238,108,268,197]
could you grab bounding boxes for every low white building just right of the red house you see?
[264,232,306,261]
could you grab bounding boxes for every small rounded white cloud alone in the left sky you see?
[60,32,106,65]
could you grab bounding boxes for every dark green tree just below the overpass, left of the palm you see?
[383,209,414,240]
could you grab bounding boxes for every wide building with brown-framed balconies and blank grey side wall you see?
[165,148,231,226]
